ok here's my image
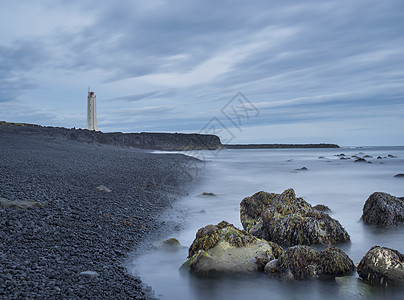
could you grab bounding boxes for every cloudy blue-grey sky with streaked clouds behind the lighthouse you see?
[0,0,404,146]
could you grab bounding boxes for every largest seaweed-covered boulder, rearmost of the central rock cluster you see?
[240,189,350,246]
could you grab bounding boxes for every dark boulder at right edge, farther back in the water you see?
[362,192,404,226]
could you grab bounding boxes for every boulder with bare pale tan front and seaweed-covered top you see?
[181,221,283,274]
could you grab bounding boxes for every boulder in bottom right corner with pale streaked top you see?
[357,246,404,287]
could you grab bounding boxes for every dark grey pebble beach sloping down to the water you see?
[0,132,199,299]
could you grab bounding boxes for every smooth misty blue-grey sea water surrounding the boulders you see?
[129,147,404,300]
